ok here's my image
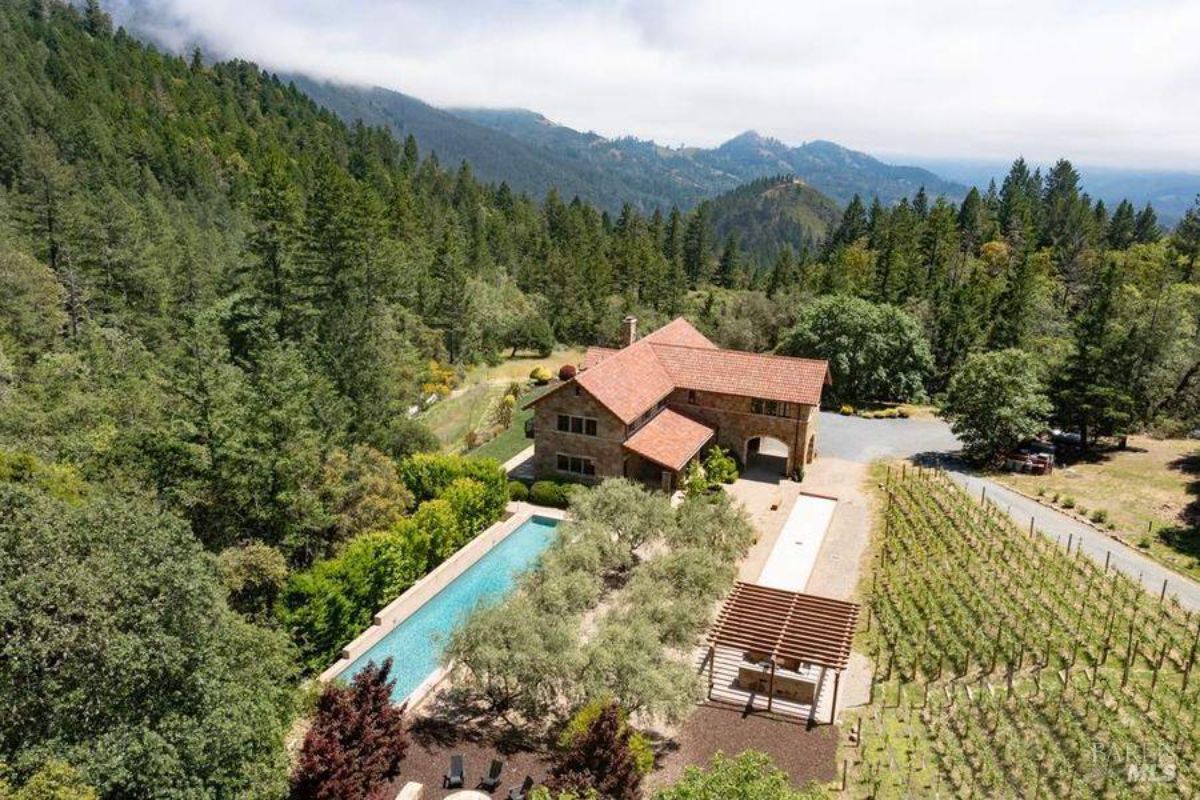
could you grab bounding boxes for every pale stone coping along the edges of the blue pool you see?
[320,503,565,705]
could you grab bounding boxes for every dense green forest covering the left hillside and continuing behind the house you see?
[0,0,1200,798]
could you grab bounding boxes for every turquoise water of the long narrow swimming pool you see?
[340,517,558,703]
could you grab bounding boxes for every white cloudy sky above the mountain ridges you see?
[109,0,1200,170]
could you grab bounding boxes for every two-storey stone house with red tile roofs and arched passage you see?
[529,317,830,491]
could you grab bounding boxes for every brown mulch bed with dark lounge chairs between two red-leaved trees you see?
[384,696,550,800]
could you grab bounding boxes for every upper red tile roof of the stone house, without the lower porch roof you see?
[529,317,830,425]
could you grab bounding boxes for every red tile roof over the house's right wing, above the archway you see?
[653,344,830,405]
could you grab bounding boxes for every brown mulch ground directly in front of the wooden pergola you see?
[647,704,838,788]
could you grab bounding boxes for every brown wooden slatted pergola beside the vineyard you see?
[708,582,859,722]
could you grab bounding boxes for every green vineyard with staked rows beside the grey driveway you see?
[846,468,1200,798]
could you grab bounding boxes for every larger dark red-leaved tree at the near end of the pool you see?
[292,658,408,800]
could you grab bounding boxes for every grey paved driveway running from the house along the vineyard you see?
[817,413,1200,609]
